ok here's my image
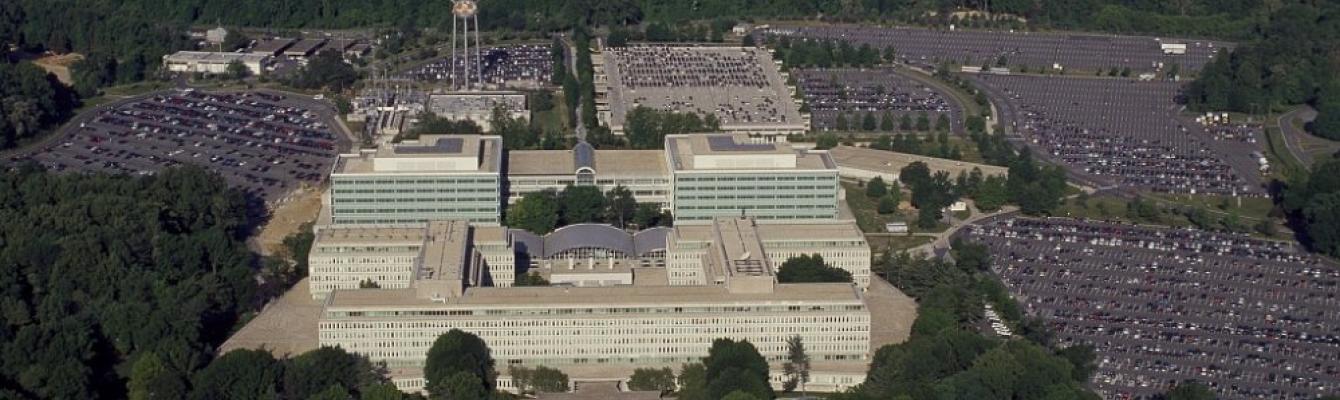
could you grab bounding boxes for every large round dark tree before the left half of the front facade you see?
[423,329,496,399]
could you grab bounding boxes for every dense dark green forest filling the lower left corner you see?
[0,166,261,399]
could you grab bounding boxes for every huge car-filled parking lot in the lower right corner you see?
[969,218,1340,399]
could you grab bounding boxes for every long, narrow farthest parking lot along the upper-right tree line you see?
[758,27,1230,72]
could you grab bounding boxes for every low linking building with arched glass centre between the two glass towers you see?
[507,142,670,206]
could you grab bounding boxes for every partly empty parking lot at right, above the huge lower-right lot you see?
[969,75,1264,194]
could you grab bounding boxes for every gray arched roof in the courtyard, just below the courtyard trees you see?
[509,223,671,258]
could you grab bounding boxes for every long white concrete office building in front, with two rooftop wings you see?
[312,218,871,391]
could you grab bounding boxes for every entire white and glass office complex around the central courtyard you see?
[308,128,911,391]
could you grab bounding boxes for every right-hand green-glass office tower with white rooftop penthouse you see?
[665,134,839,225]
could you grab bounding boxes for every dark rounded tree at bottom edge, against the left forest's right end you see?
[190,349,280,400]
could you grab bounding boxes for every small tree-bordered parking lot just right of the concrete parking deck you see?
[791,68,963,132]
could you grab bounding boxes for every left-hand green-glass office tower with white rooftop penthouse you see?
[322,135,503,226]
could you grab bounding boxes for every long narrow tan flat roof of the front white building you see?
[326,284,862,310]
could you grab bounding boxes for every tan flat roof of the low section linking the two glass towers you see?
[507,150,670,177]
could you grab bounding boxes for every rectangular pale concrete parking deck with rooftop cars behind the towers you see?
[603,45,808,131]
